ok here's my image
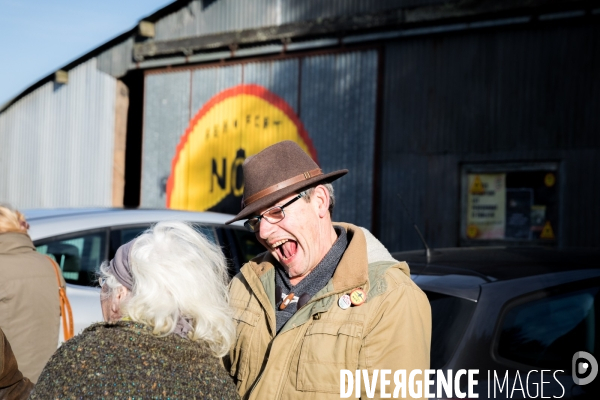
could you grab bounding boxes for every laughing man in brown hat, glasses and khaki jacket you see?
[225,141,431,399]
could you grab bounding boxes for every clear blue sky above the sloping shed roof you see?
[0,0,172,105]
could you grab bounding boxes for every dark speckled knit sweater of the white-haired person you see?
[29,321,238,399]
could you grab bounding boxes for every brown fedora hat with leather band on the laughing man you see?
[226,140,348,224]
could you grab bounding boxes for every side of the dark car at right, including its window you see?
[454,274,600,399]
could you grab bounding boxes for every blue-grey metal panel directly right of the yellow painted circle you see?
[300,50,377,228]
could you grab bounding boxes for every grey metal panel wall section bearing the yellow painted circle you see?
[140,50,379,228]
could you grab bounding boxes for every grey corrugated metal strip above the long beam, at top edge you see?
[155,0,443,40]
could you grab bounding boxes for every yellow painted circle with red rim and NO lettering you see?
[167,85,317,213]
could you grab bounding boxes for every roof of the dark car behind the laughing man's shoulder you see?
[393,246,600,282]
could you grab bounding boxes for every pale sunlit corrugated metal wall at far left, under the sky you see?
[0,58,116,208]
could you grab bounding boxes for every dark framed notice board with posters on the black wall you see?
[461,163,559,243]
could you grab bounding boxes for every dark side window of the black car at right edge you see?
[493,278,600,398]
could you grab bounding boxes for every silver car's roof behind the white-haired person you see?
[22,208,242,241]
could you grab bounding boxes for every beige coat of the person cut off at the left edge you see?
[0,232,60,383]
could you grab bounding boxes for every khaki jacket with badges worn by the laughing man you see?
[224,223,431,400]
